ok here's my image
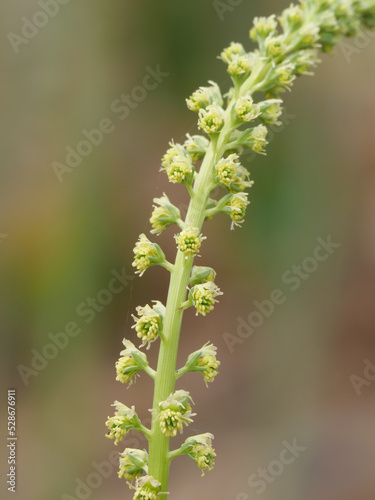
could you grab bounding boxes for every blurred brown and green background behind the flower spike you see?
[0,0,375,500]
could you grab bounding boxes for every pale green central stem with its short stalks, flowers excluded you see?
[137,0,374,500]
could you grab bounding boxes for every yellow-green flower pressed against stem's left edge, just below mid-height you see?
[132,300,165,346]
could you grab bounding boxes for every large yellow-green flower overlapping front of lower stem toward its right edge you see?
[157,390,195,437]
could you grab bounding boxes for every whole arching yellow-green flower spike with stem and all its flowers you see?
[106,0,375,500]
